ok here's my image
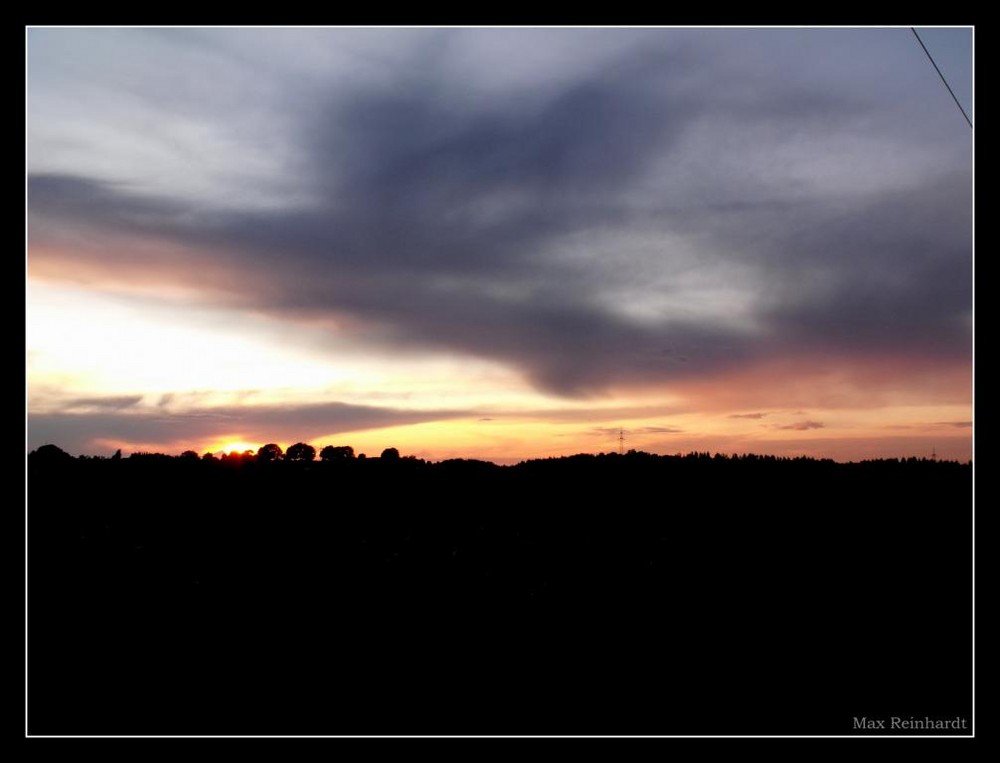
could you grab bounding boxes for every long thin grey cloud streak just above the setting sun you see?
[28,403,467,454]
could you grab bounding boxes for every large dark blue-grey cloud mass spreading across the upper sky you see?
[28,30,971,396]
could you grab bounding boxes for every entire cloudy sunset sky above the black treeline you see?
[26,27,975,463]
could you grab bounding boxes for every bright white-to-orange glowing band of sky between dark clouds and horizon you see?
[27,279,972,463]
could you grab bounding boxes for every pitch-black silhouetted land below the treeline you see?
[28,454,972,734]
